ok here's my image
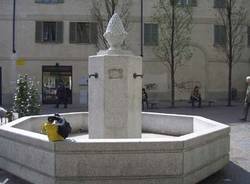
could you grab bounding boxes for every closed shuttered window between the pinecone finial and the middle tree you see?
[144,24,158,46]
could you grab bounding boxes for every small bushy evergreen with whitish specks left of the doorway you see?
[13,74,40,117]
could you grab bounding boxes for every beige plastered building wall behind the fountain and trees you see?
[0,0,250,104]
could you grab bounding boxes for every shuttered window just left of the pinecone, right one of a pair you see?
[69,22,97,44]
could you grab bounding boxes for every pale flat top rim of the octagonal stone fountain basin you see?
[0,112,230,144]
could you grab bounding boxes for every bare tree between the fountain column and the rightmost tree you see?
[153,0,192,107]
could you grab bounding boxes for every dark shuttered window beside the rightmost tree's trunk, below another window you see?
[214,25,227,46]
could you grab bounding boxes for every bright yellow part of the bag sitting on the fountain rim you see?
[41,117,64,142]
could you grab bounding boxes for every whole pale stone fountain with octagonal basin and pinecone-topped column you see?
[0,14,230,184]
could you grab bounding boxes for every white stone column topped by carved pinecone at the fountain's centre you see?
[88,15,142,138]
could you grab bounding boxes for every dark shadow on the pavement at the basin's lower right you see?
[198,161,250,184]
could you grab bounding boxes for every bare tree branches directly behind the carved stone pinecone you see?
[91,0,131,49]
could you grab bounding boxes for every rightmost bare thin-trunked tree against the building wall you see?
[217,0,247,106]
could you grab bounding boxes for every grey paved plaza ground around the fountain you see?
[0,103,250,184]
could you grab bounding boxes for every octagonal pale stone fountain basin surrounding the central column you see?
[0,112,230,184]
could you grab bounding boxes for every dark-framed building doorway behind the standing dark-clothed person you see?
[42,64,72,104]
